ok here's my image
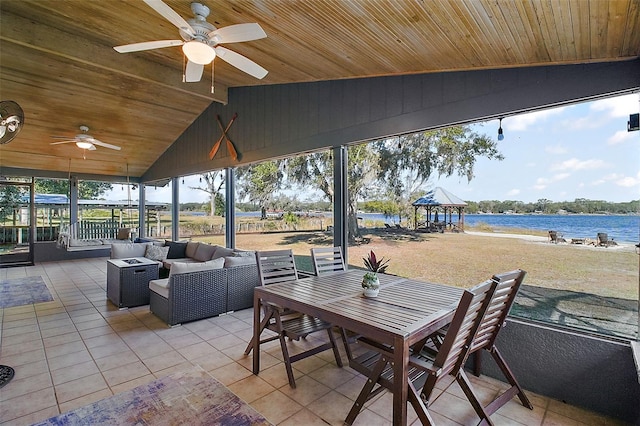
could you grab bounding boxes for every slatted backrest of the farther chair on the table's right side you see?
[471,269,527,352]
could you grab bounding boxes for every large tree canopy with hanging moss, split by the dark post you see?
[287,126,503,239]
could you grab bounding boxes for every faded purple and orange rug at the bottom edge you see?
[36,367,271,426]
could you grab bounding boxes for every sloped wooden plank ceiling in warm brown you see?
[0,0,640,177]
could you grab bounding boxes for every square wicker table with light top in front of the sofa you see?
[107,257,159,308]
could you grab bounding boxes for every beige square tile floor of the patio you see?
[0,258,632,426]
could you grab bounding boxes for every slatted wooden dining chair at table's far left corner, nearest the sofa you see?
[244,250,342,388]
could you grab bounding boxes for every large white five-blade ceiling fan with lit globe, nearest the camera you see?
[114,0,268,82]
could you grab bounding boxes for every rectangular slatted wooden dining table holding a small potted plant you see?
[253,269,463,425]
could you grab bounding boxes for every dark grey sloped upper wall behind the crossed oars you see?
[143,60,640,185]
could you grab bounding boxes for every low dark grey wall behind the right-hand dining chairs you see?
[482,320,640,425]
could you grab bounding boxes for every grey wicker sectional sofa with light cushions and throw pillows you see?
[111,242,260,326]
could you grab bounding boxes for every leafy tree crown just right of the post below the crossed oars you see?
[236,160,284,215]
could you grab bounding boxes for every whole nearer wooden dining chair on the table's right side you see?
[345,280,497,425]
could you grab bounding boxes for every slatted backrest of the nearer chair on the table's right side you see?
[433,280,498,375]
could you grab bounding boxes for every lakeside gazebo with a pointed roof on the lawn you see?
[411,186,467,232]
